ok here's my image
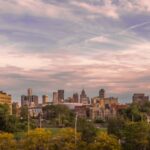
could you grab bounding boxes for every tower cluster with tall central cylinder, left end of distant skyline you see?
[21,89,38,107]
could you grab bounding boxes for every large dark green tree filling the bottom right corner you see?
[123,122,150,150]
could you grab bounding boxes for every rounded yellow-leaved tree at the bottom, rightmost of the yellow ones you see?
[88,132,121,150]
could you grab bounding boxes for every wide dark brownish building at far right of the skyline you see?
[132,93,149,103]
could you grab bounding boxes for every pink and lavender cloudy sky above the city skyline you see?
[0,0,150,102]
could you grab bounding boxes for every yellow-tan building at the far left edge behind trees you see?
[0,91,12,113]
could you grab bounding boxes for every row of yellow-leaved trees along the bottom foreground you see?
[0,128,120,150]
